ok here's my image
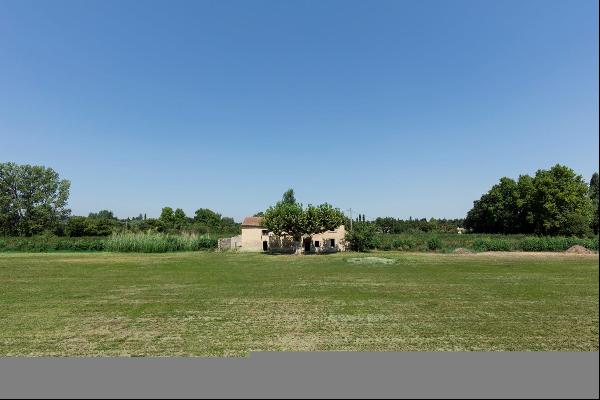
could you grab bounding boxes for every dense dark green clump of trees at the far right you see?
[465,164,598,236]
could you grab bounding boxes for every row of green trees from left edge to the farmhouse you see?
[0,163,240,237]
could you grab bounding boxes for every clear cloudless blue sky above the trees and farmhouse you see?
[0,0,599,220]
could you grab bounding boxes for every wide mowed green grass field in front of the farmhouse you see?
[0,252,598,356]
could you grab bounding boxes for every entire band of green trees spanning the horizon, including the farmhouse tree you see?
[0,162,600,238]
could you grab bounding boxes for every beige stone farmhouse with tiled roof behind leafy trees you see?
[219,217,346,253]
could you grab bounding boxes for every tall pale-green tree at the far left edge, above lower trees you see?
[0,162,71,236]
